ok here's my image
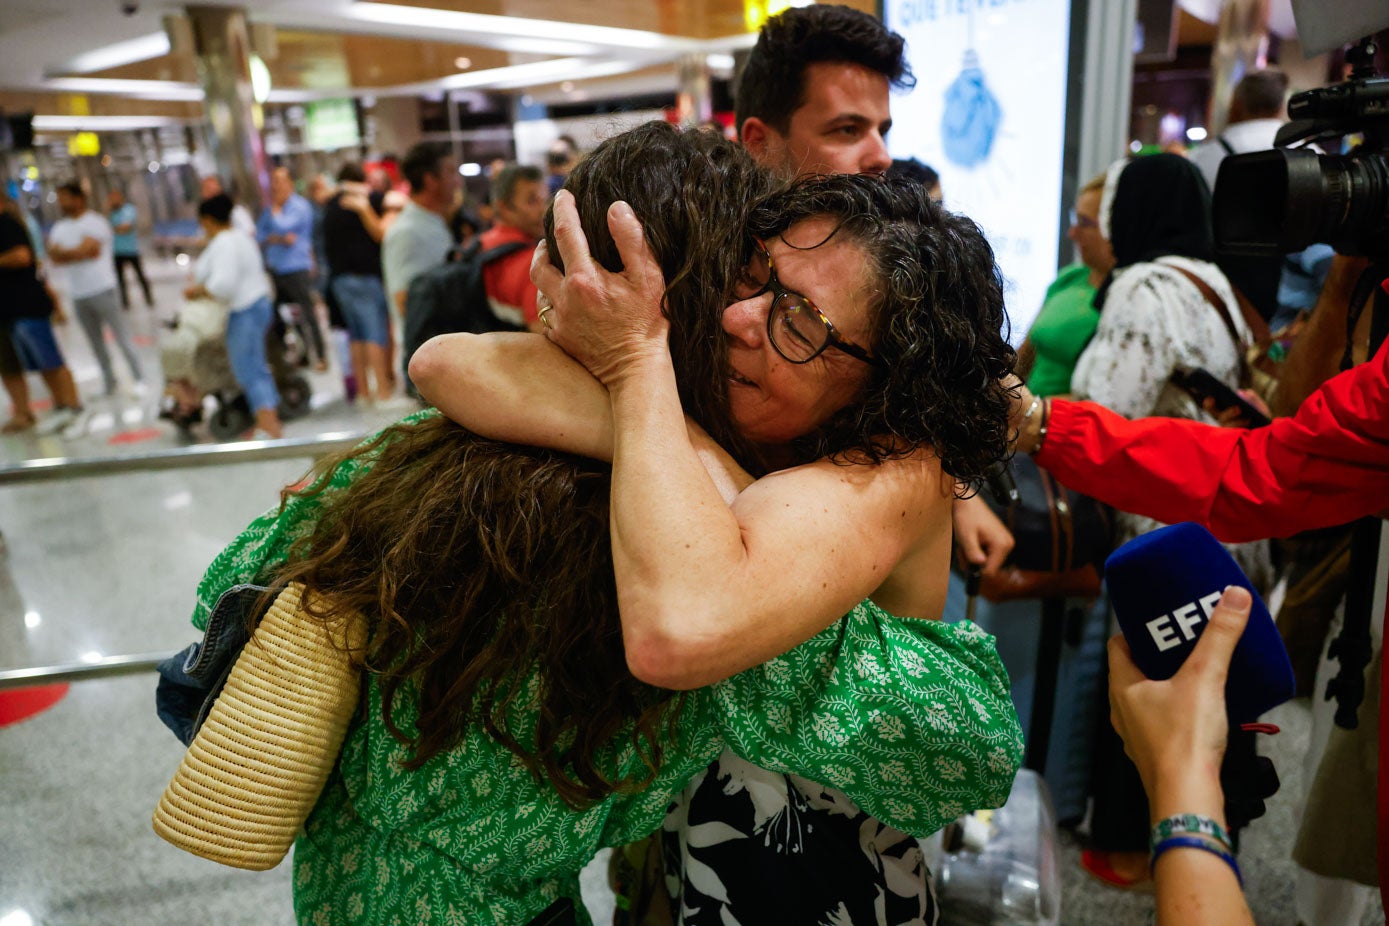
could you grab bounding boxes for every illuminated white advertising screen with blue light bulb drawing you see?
[882,0,1071,343]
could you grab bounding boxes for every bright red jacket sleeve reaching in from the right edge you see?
[1036,343,1389,543]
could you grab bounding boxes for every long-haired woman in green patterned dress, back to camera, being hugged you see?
[194,126,1021,923]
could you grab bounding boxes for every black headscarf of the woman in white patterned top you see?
[1095,154,1215,308]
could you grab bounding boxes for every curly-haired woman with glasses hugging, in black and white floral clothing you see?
[411,152,1011,925]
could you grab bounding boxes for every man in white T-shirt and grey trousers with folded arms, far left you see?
[47,183,144,396]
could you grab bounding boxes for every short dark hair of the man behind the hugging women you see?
[733,4,915,136]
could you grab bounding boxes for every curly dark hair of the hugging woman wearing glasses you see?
[749,175,1015,486]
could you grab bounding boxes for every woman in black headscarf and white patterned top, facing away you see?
[1071,154,1272,887]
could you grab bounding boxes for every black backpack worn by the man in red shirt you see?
[403,240,532,368]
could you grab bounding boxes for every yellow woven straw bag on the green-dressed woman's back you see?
[154,583,365,872]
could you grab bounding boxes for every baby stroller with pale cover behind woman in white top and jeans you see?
[161,301,313,440]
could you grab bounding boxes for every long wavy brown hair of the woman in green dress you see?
[265,124,772,807]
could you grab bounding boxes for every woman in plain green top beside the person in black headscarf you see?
[1018,174,1114,396]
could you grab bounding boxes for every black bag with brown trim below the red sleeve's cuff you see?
[979,454,1114,601]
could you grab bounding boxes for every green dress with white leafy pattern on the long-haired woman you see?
[193,412,1022,926]
